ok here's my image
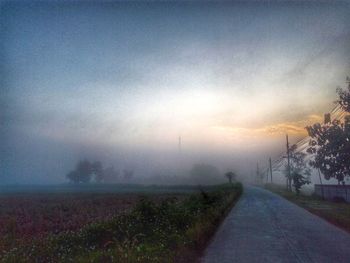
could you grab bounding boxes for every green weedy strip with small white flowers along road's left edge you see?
[0,183,242,262]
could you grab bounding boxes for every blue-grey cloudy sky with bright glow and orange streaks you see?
[0,1,350,183]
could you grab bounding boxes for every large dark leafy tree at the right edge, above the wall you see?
[306,78,350,184]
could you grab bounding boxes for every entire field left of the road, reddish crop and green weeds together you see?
[0,186,241,262]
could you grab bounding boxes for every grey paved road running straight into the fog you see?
[202,187,350,263]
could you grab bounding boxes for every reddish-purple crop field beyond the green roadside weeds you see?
[0,193,185,255]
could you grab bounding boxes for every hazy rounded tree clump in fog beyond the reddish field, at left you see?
[66,160,134,184]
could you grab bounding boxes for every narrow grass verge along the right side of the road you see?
[265,184,350,233]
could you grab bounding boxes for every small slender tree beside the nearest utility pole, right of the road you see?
[286,145,311,194]
